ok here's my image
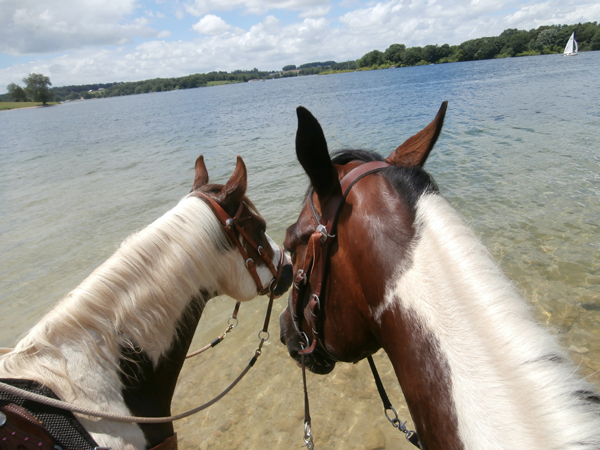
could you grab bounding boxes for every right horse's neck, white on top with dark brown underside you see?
[375,195,600,449]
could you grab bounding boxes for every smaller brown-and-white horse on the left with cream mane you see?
[0,156,291,450]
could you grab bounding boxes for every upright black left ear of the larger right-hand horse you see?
[296,106,341,199]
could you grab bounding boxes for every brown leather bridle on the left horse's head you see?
[192,191,283,295]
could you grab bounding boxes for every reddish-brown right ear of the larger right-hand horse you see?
[385,101,448,168]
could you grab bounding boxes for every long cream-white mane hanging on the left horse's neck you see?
[0,196,231,388]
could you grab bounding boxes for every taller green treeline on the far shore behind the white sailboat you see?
[356,22,600,69]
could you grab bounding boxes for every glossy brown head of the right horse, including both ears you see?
[280,102,447,374]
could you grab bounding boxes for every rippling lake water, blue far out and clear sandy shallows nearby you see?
[0,52,600,450]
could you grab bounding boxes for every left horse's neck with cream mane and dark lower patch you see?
[0,197,228,415]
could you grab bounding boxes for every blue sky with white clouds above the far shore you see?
[0,0,600,93]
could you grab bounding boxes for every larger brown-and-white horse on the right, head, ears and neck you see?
[280,102,600,450]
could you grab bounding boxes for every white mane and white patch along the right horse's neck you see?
[384,194,600,450]
